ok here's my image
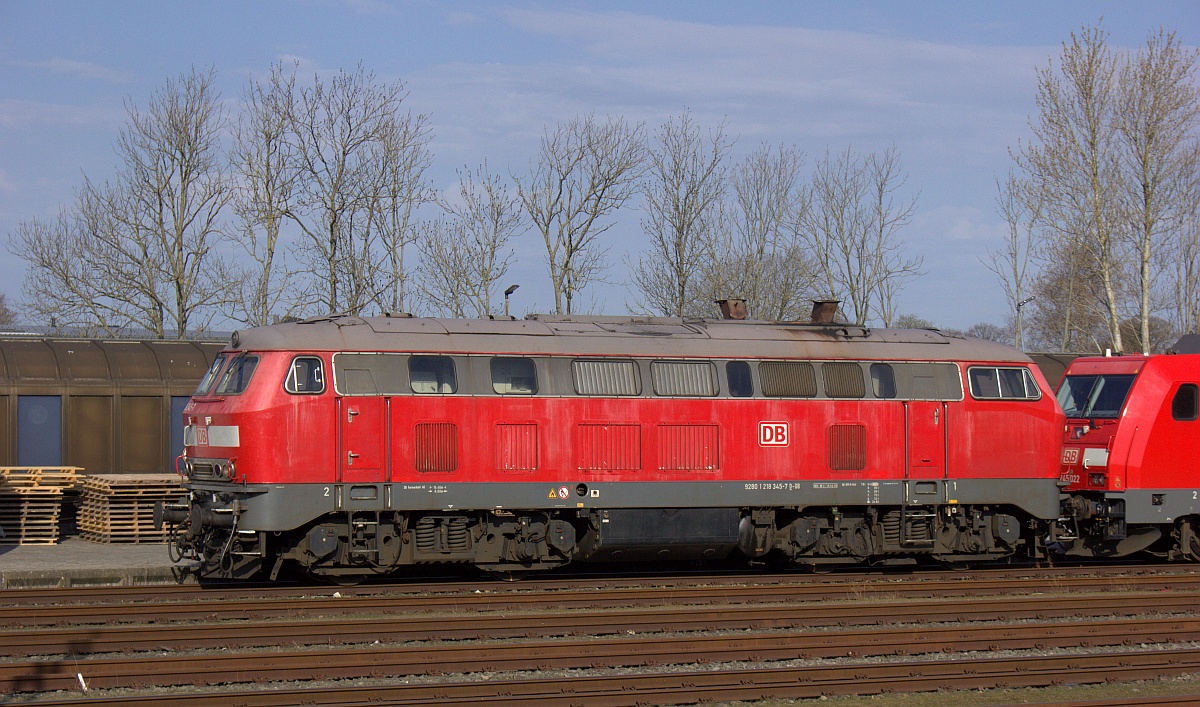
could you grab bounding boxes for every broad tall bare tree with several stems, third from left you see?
[279,66,432,313]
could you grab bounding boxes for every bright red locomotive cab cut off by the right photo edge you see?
[1058,337,1200,559]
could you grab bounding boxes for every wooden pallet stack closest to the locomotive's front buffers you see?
[79,474,186,544]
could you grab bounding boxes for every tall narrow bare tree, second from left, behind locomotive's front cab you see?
[230,65,302,326]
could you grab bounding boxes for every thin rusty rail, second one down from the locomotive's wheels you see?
[0,575,1200,627]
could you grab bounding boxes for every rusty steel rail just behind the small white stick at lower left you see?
[7,618,1200,694]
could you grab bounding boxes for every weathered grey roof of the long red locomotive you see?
[232,314,1030,363]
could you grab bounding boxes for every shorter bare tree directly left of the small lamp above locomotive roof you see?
[416,163,522,317]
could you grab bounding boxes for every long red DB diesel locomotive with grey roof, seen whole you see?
[162,308,1064,577]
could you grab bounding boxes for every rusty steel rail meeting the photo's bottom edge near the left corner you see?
[18,649,1200,707]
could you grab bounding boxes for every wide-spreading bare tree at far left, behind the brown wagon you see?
[10,70,233,338]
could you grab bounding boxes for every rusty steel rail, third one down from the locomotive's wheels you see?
[7,592,1200,658]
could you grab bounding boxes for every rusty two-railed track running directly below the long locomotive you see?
[0,559,1200,627]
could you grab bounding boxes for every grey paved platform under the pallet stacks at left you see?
[0,537,196,589]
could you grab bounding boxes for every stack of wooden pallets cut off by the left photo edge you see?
[0,467,83,545]
